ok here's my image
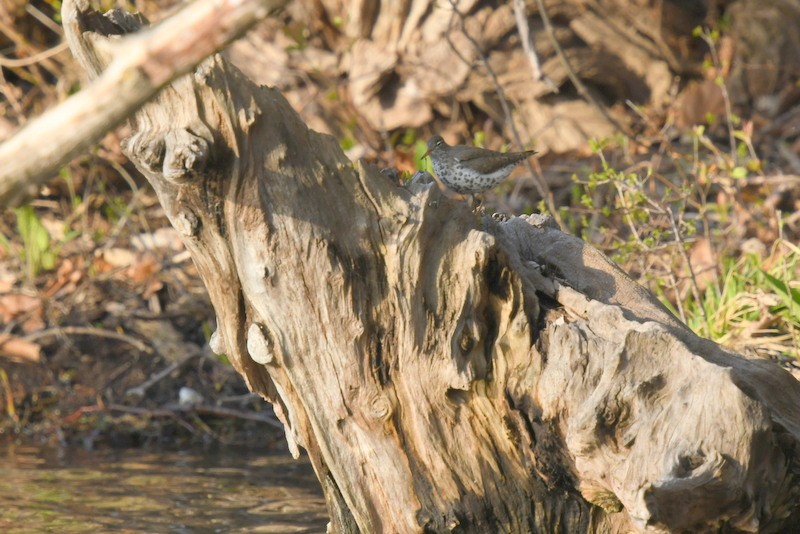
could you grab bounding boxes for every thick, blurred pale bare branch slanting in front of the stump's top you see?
[0,0,286,207]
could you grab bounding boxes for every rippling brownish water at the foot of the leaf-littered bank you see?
[0,446,328,534]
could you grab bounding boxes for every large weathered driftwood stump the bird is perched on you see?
[63,0,800,533]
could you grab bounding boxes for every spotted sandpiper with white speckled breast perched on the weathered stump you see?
[425,135,536,195]
